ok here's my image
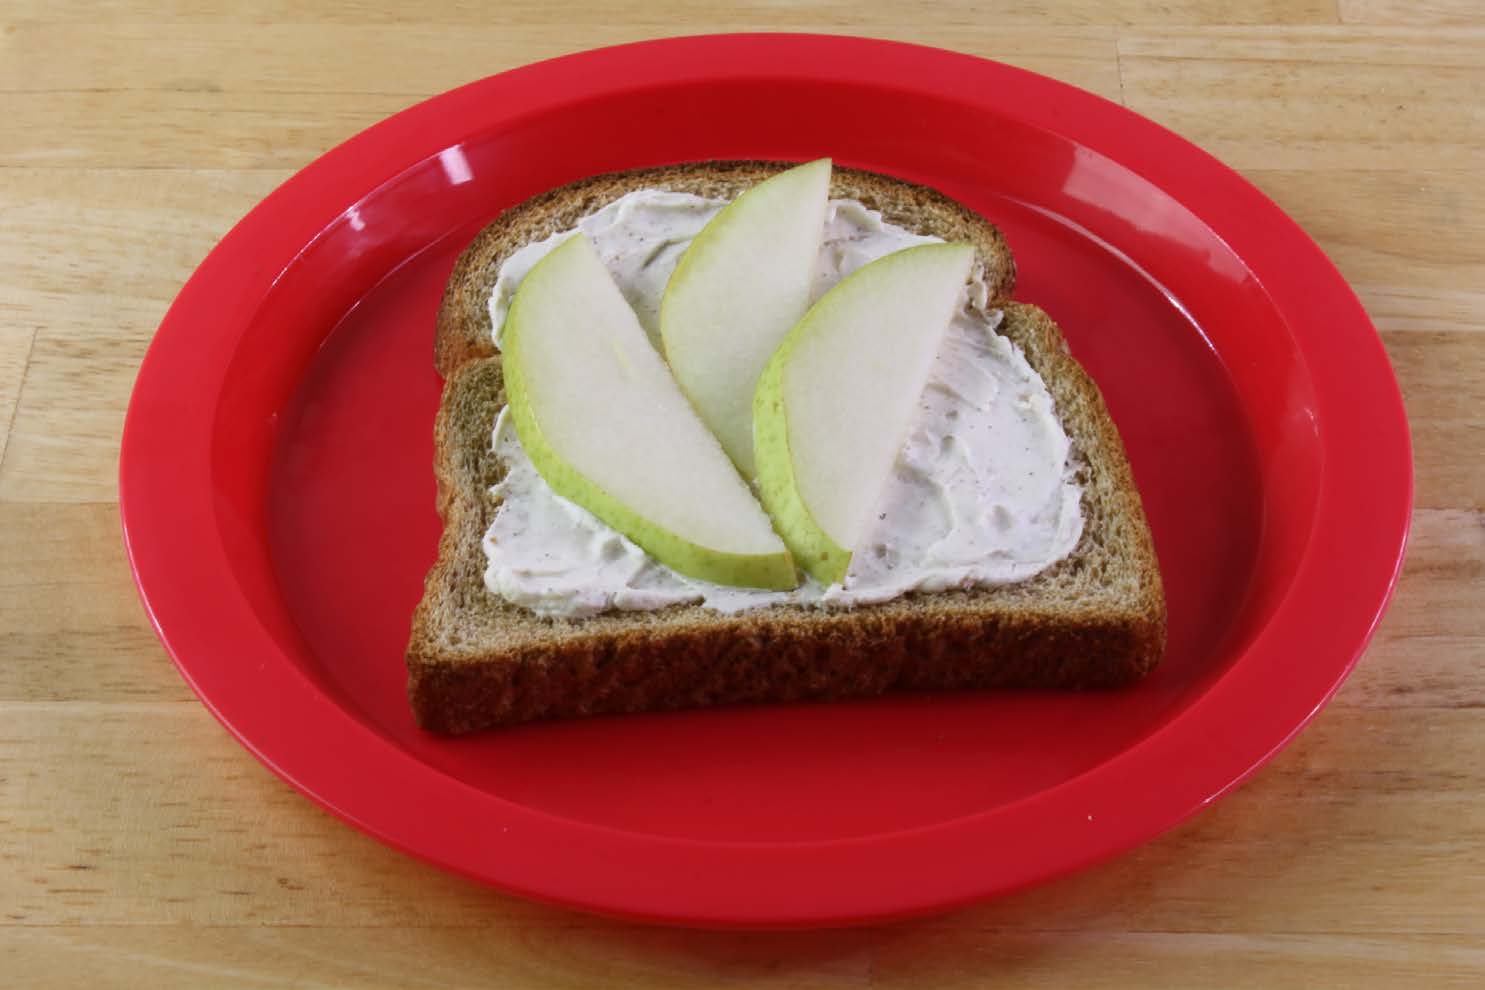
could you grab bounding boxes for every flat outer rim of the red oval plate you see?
[119,33,1412,928]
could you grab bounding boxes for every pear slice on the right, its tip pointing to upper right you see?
[753,243,974,585]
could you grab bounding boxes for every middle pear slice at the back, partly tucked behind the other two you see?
[659,159,830,478]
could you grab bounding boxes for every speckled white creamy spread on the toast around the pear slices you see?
[484,190,1083,617]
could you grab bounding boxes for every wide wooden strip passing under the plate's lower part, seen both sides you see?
[0,702,1485,937]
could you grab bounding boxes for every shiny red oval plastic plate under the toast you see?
[120,34,1412,926]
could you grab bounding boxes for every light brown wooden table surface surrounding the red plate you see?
[0,0,1485,990]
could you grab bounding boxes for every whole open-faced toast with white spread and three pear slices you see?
[407,160,1166,733]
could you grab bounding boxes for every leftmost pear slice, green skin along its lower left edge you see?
[502,235,797,589]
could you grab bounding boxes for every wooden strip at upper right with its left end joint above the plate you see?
[1118,27,1485,172]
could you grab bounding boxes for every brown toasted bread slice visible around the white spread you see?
[407,162,1166,733]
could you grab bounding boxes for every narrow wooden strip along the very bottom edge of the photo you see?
[0,926,1482,990]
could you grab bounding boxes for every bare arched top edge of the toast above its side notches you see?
[434,162,1016,378]
